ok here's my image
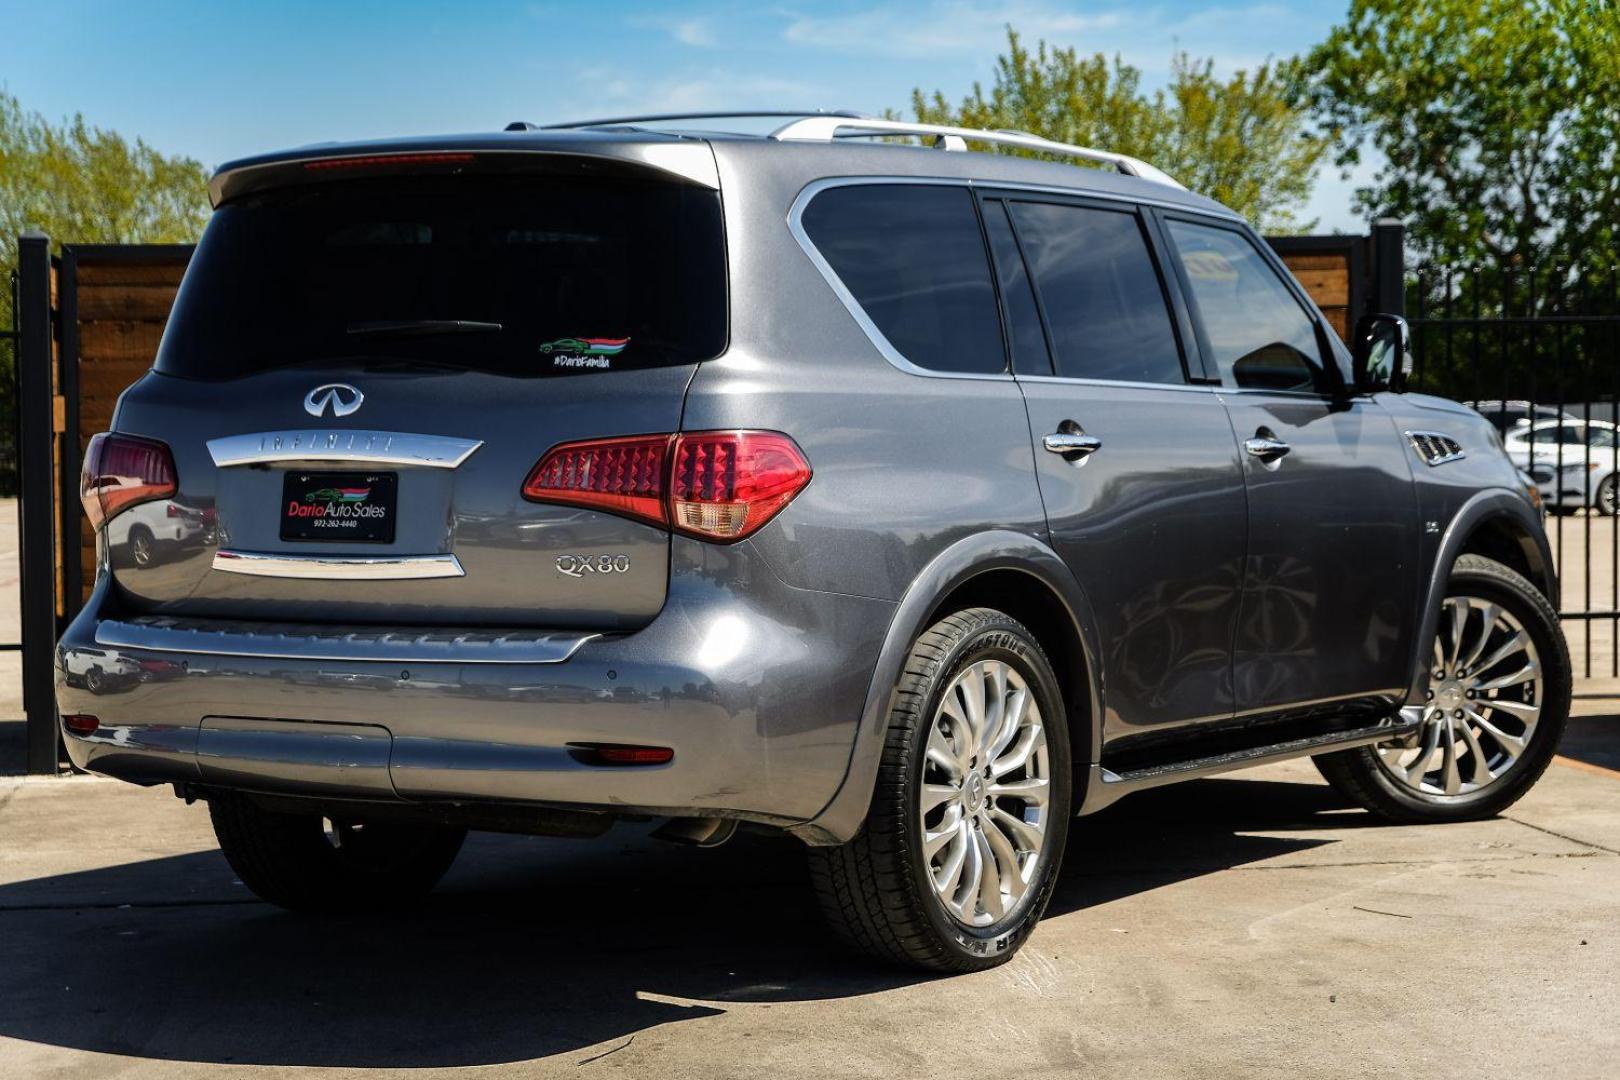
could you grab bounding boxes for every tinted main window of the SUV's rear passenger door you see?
[1008,202,1186,382]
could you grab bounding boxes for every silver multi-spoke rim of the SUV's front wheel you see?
[1377,596,1542,797]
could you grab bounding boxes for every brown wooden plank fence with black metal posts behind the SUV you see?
[3,223,1401,772]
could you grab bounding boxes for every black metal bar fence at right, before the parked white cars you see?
[1406,266,1620,677]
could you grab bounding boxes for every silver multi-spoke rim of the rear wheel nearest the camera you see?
[920,661,1051,926]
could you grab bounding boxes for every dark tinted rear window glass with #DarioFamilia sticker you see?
[157,175,726,379]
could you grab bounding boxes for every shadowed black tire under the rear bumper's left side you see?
[209,792,467,913]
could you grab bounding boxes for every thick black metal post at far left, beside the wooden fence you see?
[16,233,60,772]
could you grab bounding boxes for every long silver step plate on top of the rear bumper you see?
[96,615,601,664]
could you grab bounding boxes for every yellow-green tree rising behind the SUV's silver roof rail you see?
[912,28,1327,232]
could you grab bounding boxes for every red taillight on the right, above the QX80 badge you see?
[523,431,810,541]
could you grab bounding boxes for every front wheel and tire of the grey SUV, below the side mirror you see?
[1315,555,1570,823]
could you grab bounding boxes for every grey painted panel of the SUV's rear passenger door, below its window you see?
[1024,381,1246,738]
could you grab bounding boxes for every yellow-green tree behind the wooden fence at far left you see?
[0,91,209,325]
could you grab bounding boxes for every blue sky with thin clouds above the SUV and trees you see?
[0,0,1361,232]
